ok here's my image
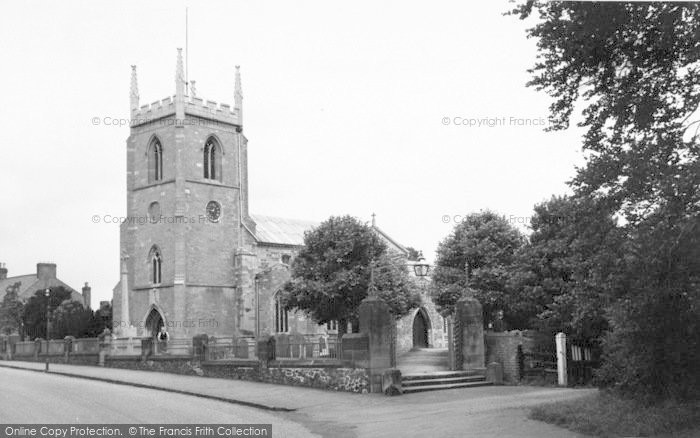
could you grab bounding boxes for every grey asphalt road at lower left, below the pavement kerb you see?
[0,368,319,438]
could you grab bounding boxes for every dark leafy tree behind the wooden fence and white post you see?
[509,196,625,340]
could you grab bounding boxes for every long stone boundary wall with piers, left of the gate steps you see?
[2,330,378,393]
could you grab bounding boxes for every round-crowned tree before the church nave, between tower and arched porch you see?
[282,216,420,330]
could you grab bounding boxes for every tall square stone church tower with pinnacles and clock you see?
[114,49,255,338]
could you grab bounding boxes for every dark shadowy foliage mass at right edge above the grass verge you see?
[599,212,700,400]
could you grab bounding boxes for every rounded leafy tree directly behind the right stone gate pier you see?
[432,211,525,326]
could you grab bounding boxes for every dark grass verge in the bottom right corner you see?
[530,392,700,437]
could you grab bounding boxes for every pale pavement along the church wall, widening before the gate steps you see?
[0,361,592,438]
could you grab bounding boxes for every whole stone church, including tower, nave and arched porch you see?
[113,49,444,352]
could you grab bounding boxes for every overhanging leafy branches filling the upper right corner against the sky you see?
[512,1,700,222]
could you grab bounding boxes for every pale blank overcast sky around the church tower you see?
[0,1,582,305]
